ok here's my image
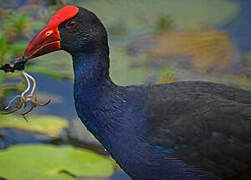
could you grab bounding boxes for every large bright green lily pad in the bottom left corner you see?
[0,145,113,180]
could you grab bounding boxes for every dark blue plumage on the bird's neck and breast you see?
[69,39,219,179]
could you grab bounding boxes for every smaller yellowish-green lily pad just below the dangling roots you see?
[0,115,68,137]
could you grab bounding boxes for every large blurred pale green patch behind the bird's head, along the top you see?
[80,0,240,38]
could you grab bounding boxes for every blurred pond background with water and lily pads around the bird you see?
[0,0,251,180]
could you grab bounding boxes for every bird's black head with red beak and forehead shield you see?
[24,5,107,59]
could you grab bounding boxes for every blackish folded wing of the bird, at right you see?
[146,82,251,177]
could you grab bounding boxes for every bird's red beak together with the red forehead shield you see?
[24,5,79,59]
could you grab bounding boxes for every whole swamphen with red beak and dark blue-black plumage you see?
[24,5,251,180]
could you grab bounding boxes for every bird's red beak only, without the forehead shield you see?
[24,24,61,59]
